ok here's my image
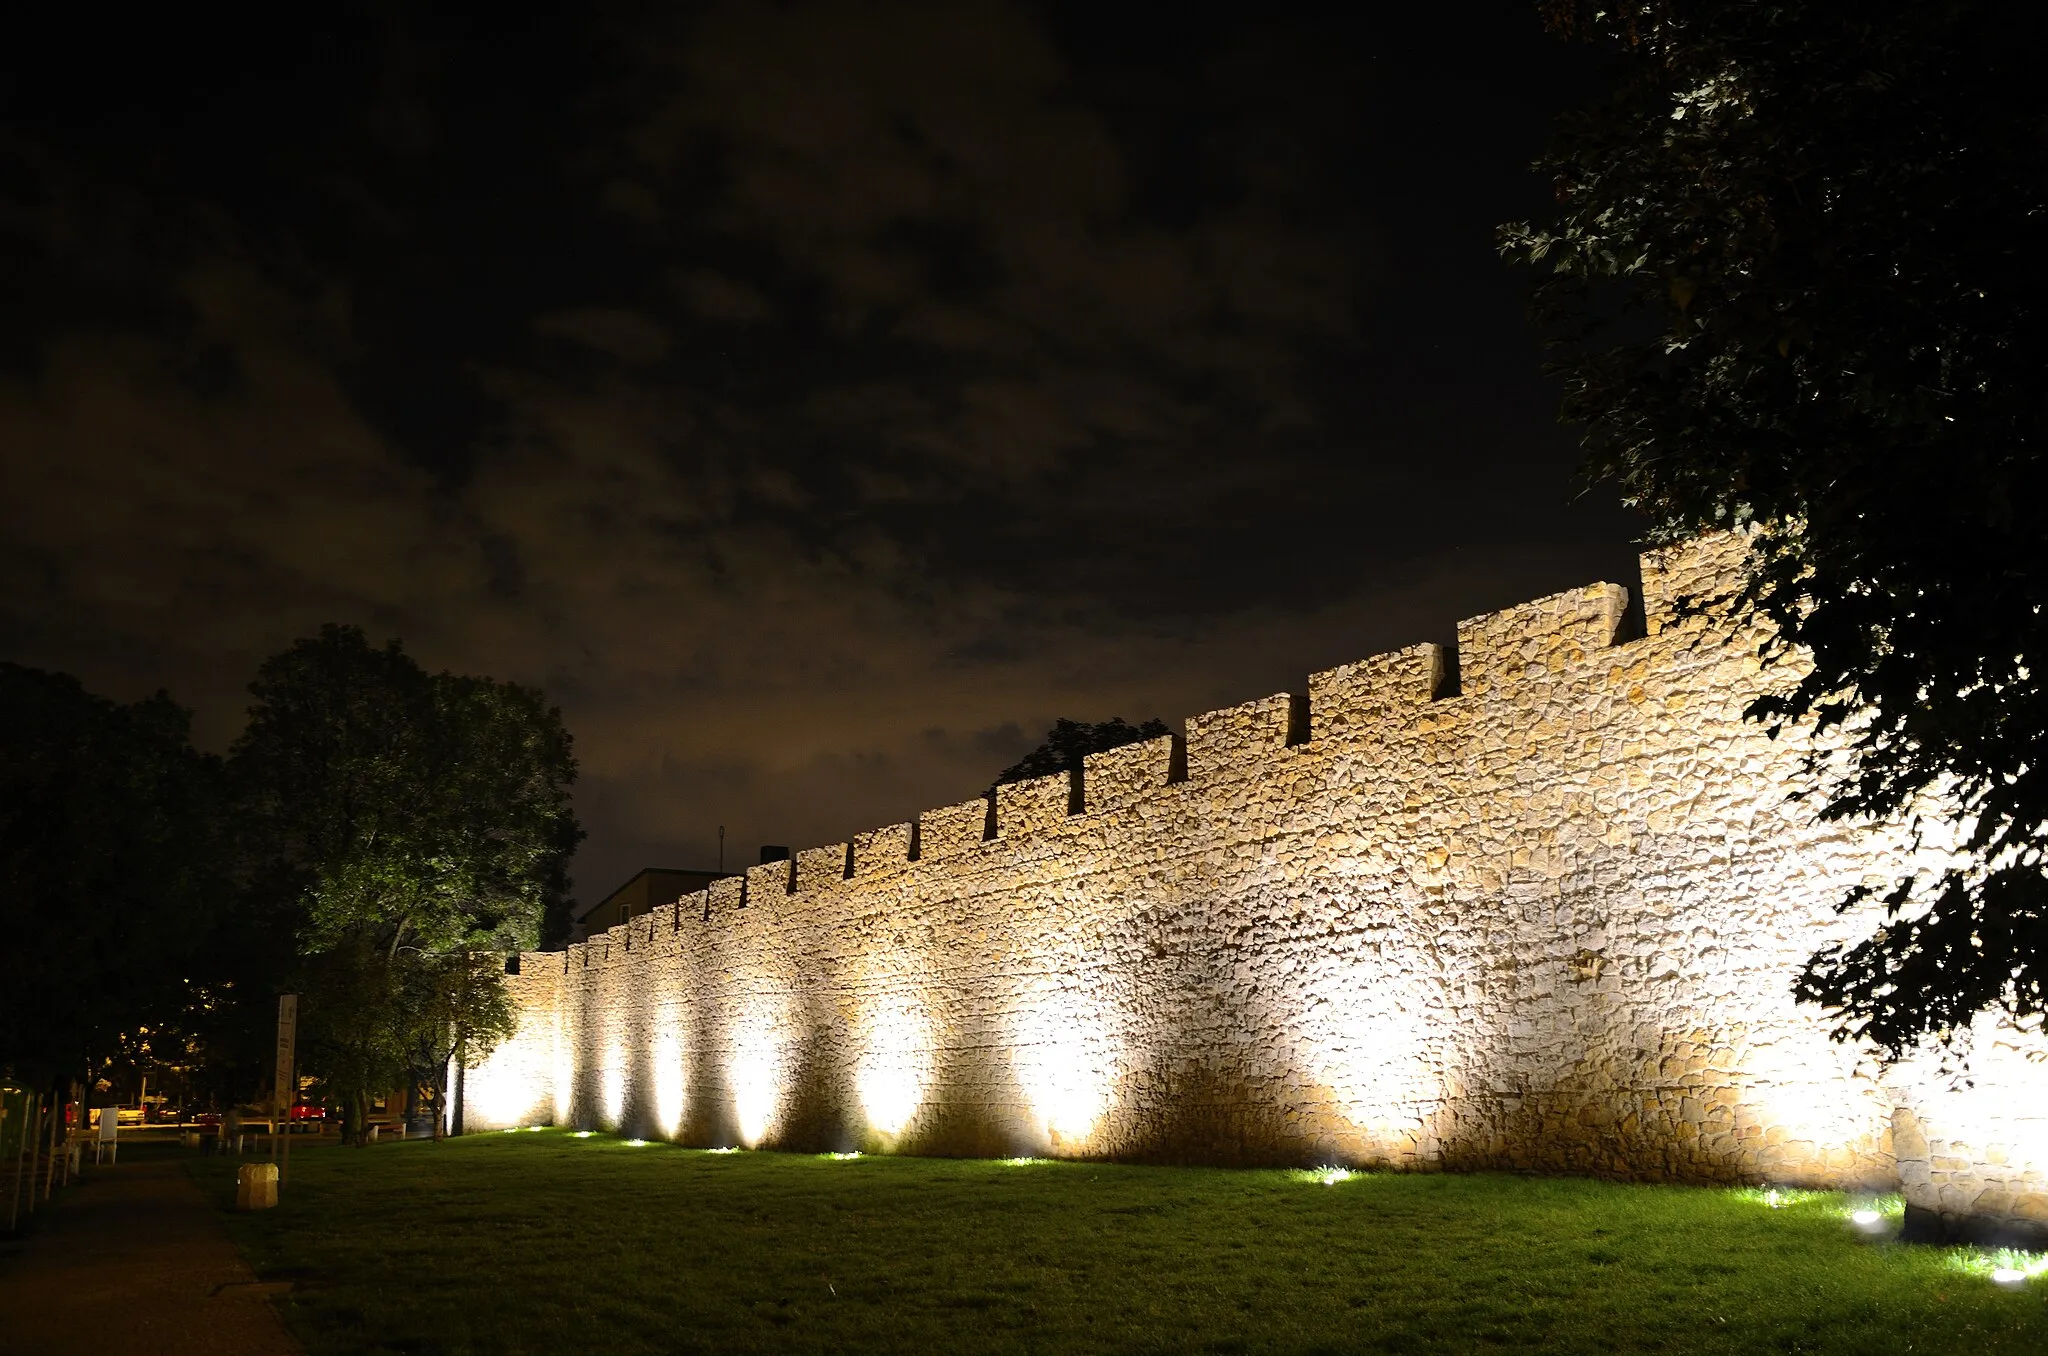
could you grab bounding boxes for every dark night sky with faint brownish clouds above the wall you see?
[0,2,1640,901]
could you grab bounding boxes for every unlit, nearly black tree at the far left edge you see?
[0,664,229,1082]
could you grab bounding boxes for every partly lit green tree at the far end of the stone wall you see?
[229,625,582,1133]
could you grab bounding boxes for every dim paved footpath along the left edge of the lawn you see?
[0,1155,299,1356]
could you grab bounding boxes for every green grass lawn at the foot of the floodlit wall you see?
[193,1131,2048,1356]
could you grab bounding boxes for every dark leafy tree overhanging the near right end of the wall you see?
[1501,0,2048,1059]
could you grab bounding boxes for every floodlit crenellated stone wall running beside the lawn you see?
[469,537,2048,1225]
